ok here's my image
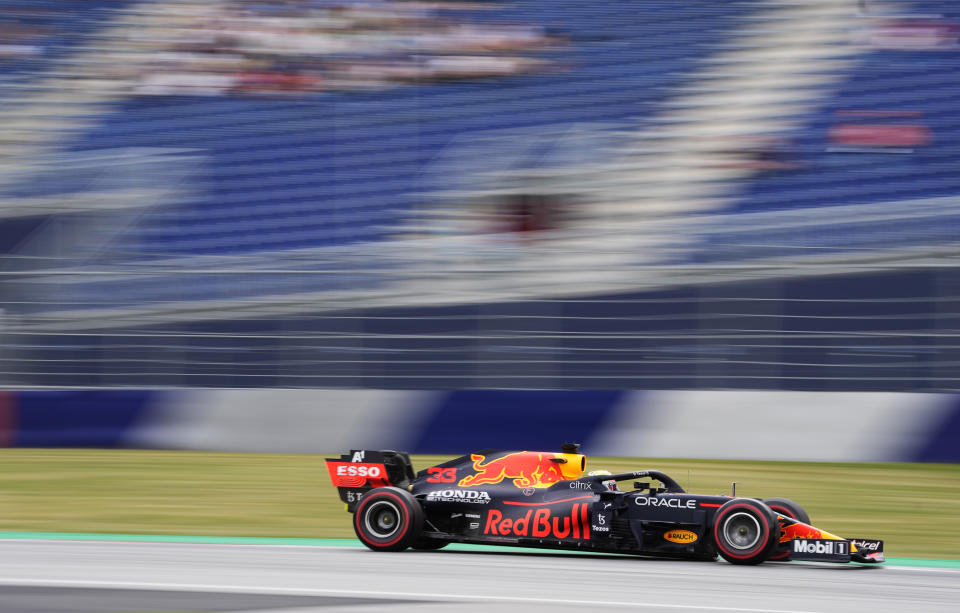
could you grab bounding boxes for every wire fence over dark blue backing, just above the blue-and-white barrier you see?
[0,254,960,391]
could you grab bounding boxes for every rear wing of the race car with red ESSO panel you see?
[327,449,414,513]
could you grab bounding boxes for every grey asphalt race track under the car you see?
[0,539,960,613]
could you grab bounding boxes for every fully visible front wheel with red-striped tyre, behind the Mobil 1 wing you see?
[713,498,780,564]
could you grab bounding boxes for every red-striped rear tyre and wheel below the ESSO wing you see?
[353,487,423,551]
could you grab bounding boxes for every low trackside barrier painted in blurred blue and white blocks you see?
[0,390,960,462]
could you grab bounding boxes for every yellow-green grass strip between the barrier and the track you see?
[0,449,960,559]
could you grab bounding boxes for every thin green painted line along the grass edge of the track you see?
[0,532,960,569]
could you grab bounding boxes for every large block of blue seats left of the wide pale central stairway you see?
[7,0,751,255]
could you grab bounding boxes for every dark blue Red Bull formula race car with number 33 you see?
[327,443,884,564]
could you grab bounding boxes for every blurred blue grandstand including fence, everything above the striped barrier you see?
[0,0,960,390]
